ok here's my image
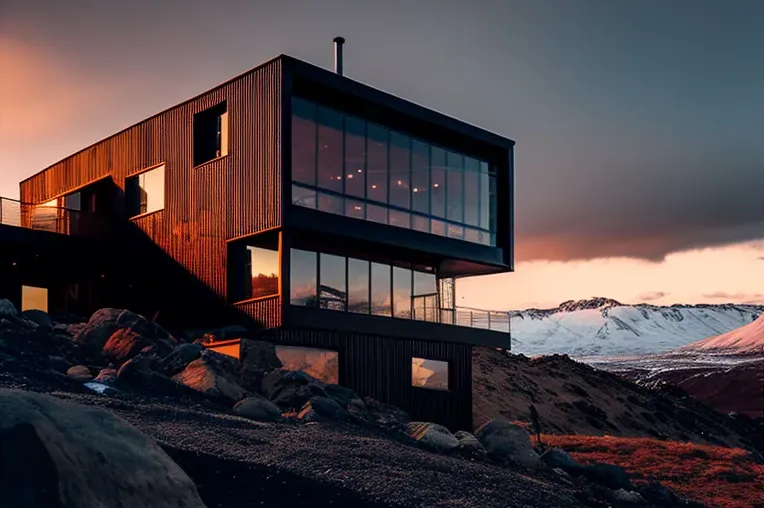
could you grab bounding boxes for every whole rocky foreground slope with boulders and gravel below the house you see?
[0,301,728,508]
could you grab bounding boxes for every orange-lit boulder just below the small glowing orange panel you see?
[172,350,249,405]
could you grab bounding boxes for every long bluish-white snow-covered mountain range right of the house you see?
[511,298,764,357]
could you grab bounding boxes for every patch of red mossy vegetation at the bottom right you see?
[542,435,764,508]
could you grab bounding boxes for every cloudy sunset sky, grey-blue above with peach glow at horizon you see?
[0,0,764,308]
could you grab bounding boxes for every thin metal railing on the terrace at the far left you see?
[0,197,106,235]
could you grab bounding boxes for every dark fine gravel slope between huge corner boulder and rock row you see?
[0,372,593,508]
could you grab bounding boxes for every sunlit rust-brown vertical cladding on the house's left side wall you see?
[20,59,283,322]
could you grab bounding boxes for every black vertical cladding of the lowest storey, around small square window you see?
[253,328,472,431]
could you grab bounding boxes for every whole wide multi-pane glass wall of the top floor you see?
[292,99,497,245]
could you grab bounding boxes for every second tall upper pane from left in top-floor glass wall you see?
[316,108,344,192]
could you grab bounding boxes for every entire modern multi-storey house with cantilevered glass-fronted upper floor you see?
[0,38,514,429]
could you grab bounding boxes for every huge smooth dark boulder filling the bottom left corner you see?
[0,389,204,508]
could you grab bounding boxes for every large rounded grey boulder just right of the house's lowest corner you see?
[475,420,543,468]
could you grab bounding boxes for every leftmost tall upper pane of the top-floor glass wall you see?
[292,99,316,185]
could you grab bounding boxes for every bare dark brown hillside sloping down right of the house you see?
[473,348,764,451]
